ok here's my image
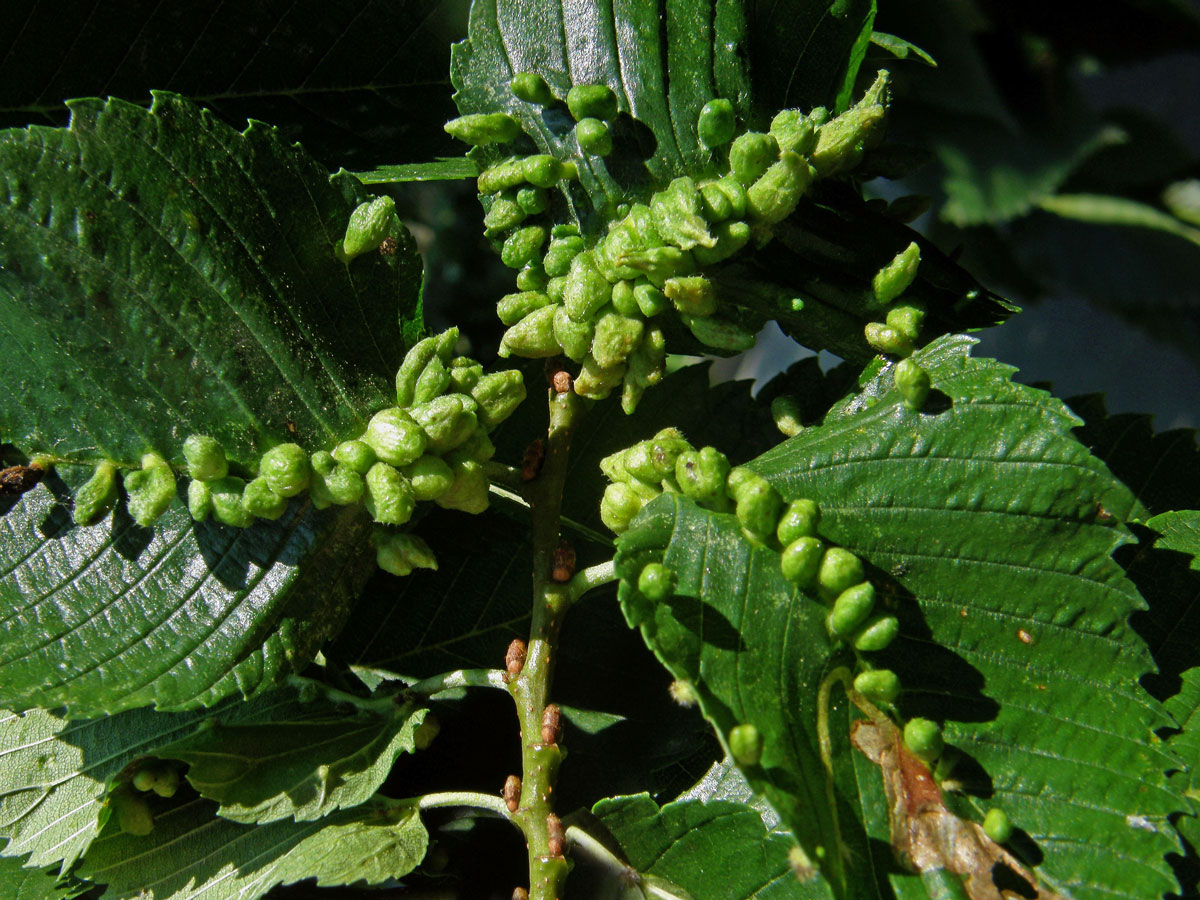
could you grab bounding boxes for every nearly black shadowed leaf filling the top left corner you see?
[0,0,468,168]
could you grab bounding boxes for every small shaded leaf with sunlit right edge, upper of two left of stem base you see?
[155,683,428,824]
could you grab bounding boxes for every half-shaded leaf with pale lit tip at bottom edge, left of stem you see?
[79,798,428,900]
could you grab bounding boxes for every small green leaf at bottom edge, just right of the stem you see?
[592,794,830,900]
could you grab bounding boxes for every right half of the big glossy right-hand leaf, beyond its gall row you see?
[752,337,1184,898]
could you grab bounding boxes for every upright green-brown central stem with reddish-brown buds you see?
[509,391,584,900]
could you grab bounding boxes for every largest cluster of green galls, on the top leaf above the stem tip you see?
[446,72,923,413]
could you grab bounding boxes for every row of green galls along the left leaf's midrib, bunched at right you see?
[74,328,526,575]
